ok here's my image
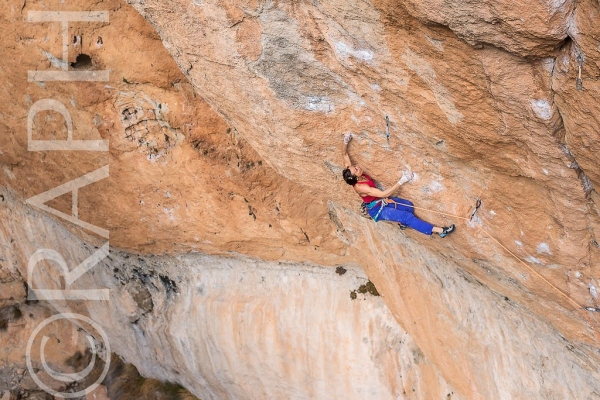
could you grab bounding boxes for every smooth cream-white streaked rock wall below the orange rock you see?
[0,195,461,399]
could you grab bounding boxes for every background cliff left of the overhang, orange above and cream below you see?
[0,1,458,398]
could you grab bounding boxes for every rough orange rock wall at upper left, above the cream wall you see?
[0,1,346,264]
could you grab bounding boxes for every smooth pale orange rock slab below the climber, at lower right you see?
[333,203,598,399]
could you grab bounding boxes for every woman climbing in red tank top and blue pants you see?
[342,133,456,237]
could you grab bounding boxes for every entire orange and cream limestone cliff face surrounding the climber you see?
[0,0,600,399]
